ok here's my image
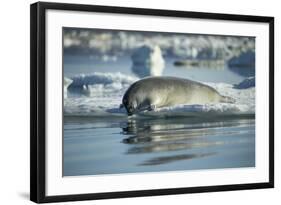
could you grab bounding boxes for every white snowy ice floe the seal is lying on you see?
[64,73,255,117]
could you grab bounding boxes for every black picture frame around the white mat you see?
[30,2,274,203]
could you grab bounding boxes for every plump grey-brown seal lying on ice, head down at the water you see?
[120,77,235,115]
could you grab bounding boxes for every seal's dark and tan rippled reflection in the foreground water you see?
[122,118,253,166]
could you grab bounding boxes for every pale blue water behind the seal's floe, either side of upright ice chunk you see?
[64,55,245,84]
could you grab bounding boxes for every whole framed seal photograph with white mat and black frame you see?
[30,2,274,203]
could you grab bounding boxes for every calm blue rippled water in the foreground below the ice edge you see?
[64,117,255,176]
